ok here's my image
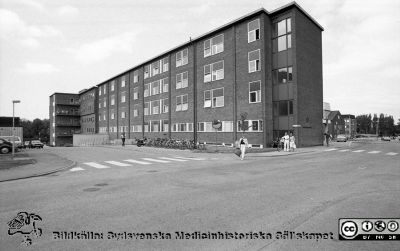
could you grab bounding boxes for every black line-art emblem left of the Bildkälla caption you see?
[7,212,42,246]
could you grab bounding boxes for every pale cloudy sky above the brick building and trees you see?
[0,0,400,121]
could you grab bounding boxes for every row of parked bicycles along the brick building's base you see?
[136,138,196,150]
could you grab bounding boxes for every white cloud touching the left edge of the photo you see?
[0,9,62,47]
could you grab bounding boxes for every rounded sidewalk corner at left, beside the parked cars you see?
[0,149,76,182]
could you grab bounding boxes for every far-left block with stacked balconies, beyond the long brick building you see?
[49,92,80,146]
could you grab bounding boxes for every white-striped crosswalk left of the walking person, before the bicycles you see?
[70,156,206,172]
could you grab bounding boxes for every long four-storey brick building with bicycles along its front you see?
[50,3,323,146]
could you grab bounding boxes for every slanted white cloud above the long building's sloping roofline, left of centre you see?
[70,32,136,64]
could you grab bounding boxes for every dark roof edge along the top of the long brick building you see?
[96,1,324,86]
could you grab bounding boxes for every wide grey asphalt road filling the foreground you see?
[0,142,400,250]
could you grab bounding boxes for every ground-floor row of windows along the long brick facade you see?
[99,119,263,133]
